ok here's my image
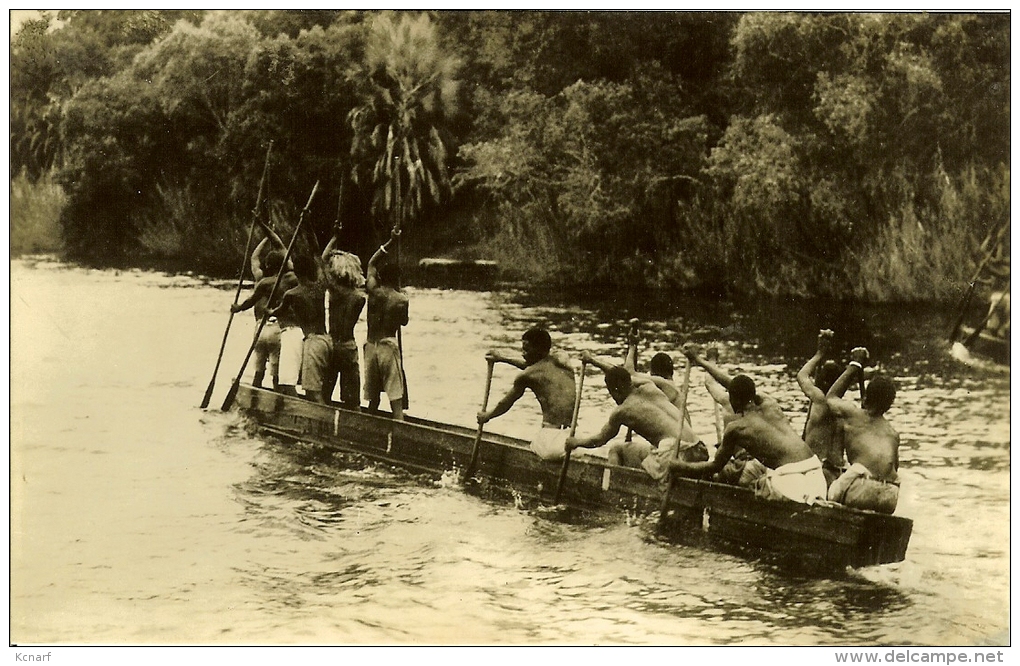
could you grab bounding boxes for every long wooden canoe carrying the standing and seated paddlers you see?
[236,386,913,570]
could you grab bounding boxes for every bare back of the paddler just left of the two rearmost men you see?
[723,396,814,469]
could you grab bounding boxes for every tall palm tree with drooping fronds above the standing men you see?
[349,13,459,236]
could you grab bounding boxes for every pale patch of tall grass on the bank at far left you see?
[10,173,67,257]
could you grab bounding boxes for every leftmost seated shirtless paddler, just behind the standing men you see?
[477,328,576,460]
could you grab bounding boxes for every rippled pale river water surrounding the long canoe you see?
[10,259,1010,646]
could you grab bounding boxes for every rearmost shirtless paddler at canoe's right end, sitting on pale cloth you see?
[827,348,900,513]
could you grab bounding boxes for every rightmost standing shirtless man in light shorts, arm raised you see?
[365,229,408,420]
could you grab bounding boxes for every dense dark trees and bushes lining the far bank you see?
[11,10,1010,300]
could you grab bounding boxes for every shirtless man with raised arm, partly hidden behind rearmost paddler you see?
[797,328,845,485]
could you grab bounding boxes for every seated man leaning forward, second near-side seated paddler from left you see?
[566,365,708,479]
